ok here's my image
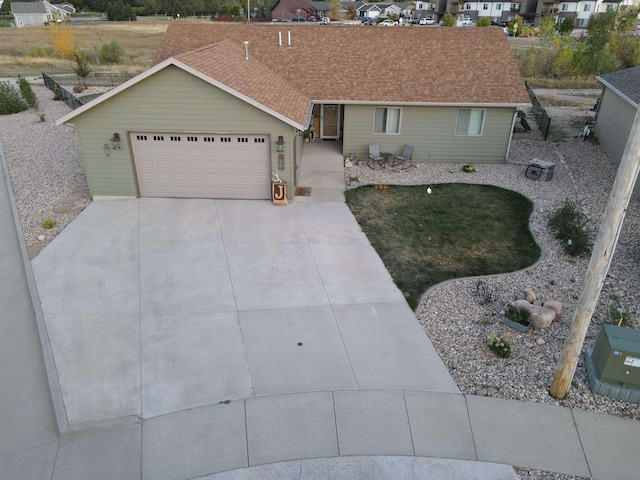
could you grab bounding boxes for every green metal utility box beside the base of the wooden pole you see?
[592,324,640,388]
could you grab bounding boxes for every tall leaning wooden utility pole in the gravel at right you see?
[549,108,640,398]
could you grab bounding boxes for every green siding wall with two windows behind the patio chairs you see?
[343,105,515,163]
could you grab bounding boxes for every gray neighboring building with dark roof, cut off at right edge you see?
[595,66,640,164]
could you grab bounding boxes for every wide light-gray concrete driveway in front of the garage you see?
[32,199,458,427]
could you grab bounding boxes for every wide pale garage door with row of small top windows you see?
[131,132,271,199]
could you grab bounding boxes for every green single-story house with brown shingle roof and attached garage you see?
[58,22,529,198]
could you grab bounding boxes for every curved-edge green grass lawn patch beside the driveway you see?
[346,183,541,309]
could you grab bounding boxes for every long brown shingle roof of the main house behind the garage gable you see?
[155,22,529,105]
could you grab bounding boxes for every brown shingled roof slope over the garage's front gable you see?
[174,40,311,126]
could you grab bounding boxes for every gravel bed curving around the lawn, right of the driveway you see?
[345,100,640,424]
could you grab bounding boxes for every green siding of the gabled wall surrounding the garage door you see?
[73,66,296,196]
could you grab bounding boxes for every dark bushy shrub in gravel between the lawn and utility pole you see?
[549,198,591,256]
